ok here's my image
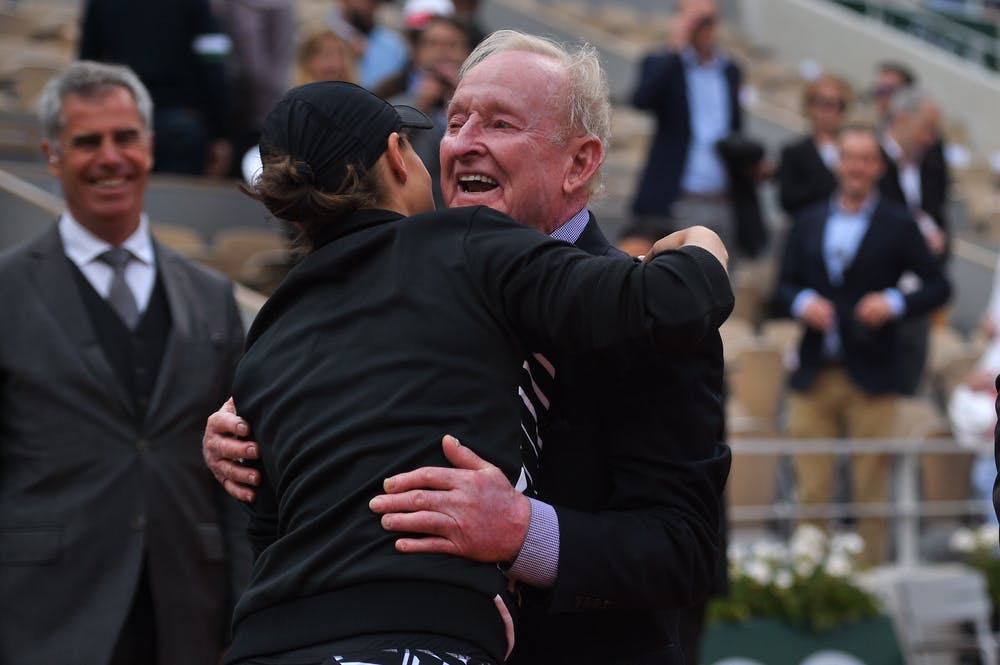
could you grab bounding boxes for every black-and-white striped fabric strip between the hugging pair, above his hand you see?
[515,353,555,496]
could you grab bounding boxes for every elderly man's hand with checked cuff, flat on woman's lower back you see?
[369,436,531,563]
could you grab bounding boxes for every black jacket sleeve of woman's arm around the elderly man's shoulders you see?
[464,208,734,353]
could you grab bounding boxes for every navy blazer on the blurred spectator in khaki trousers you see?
[775,197,951,394]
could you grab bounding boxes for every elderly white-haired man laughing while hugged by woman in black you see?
[204,31,730,664]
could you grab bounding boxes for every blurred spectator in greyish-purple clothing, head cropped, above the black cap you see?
[221,0,296,176]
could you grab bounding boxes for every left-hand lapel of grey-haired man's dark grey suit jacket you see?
[30,227,135,417]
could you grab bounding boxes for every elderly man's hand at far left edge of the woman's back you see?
[201,397,260,503]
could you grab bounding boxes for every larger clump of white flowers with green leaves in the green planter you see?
[708,525,881,631]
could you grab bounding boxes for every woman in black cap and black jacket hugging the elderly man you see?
[228,82,733,665]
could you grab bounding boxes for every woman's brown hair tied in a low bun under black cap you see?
[240,155,379,253]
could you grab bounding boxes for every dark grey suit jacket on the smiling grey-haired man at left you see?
[0,228,249,665]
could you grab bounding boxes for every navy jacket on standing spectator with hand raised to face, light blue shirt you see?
[632,52,743,216]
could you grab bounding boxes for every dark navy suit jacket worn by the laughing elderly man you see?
[510,219,730,665]
